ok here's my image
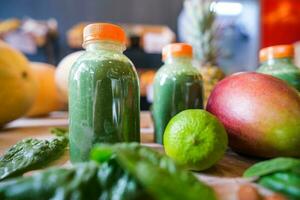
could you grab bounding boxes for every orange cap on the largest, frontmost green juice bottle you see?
[83,23,126,45]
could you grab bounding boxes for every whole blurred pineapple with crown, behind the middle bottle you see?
[184,0,225,105]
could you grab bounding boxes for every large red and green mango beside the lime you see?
[207,72,300,158]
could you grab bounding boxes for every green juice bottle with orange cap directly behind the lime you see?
[152,43,203,144]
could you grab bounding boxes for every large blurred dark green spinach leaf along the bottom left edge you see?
[0,159,152,200]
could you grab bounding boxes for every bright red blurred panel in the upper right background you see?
[261,0,300,47]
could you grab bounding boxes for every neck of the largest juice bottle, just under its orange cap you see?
[83,41,126,53]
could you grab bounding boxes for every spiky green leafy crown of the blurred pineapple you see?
[184,0,218,66]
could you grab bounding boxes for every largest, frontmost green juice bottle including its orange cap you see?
[69,23,140,163]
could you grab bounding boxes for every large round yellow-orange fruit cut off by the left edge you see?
[0,41,37,127]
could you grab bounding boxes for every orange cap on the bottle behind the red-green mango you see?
[259,45,294,62]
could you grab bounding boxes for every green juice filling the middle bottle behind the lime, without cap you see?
[153,60,203,144]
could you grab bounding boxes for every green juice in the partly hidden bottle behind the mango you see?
[257,58,300,91]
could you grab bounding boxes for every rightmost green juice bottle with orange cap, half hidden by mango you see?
[257,45,300,91]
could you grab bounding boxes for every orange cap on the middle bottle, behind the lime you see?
[162,43,193,60]
